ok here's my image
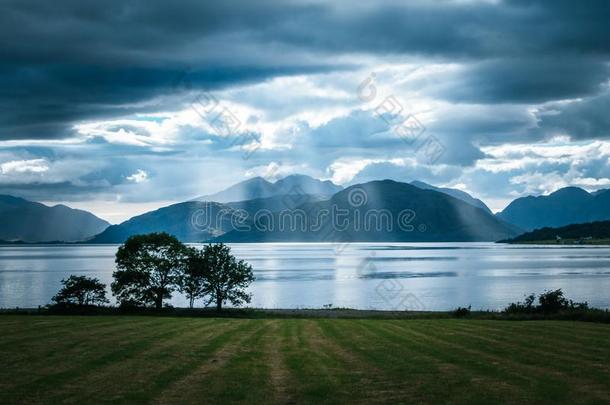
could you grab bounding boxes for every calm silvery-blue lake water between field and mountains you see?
[0,243,610,310]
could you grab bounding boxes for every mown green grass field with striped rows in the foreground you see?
[0,315,610,404]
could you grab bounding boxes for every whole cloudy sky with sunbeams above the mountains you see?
[0,0,610,223]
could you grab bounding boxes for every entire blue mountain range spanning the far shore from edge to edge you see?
[0,175,610,243]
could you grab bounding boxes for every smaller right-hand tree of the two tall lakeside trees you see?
[203,243,254,311]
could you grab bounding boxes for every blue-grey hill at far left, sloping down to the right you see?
[0,195,110,242]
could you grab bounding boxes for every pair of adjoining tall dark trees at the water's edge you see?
[111,233,254,311]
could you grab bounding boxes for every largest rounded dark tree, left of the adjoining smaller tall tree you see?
[111,233,188,309]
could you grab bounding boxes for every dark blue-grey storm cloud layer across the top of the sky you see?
[0,0,610,139]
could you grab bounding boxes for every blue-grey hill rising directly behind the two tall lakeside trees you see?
[87,201,233,243]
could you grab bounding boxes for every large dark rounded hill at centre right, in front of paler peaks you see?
[215,180,519,242]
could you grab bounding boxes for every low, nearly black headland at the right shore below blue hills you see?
[505,221,610,243]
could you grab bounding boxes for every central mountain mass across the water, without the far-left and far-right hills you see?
[88,175,519,243]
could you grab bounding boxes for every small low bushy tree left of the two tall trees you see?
[53,275,108,306]
